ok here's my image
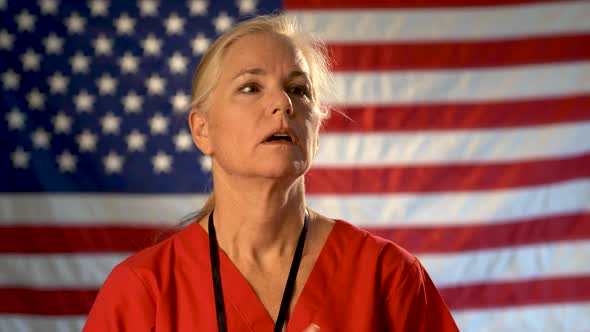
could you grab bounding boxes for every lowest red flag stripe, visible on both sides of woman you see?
[0,276,590,315]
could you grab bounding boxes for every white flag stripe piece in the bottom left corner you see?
[0,314,86,332]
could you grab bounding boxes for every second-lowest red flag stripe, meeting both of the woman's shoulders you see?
[0,213,590,254]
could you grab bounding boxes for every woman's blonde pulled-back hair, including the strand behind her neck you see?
[183,15,333,224]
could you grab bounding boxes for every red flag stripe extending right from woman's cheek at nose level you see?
[324,95,590,132]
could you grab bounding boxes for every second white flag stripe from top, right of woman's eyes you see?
[324,61,590,106]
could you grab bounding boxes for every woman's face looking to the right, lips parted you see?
[199,33,320,178]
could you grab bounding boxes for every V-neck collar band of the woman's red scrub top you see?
[195,220,343,332]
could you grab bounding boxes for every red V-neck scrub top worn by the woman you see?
[83,221,458,332]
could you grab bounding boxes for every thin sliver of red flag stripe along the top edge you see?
[283,0,555,10]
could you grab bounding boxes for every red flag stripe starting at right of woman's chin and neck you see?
[305,154,590,195]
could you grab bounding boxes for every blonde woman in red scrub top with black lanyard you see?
[85,16,457,332]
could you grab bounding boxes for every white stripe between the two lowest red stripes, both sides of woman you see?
[0,241,590,289]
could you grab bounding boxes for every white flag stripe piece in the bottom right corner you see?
[453,302,590,332]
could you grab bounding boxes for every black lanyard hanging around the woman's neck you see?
[209,211,309,332]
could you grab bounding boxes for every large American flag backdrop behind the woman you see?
[0,0,590,331]
